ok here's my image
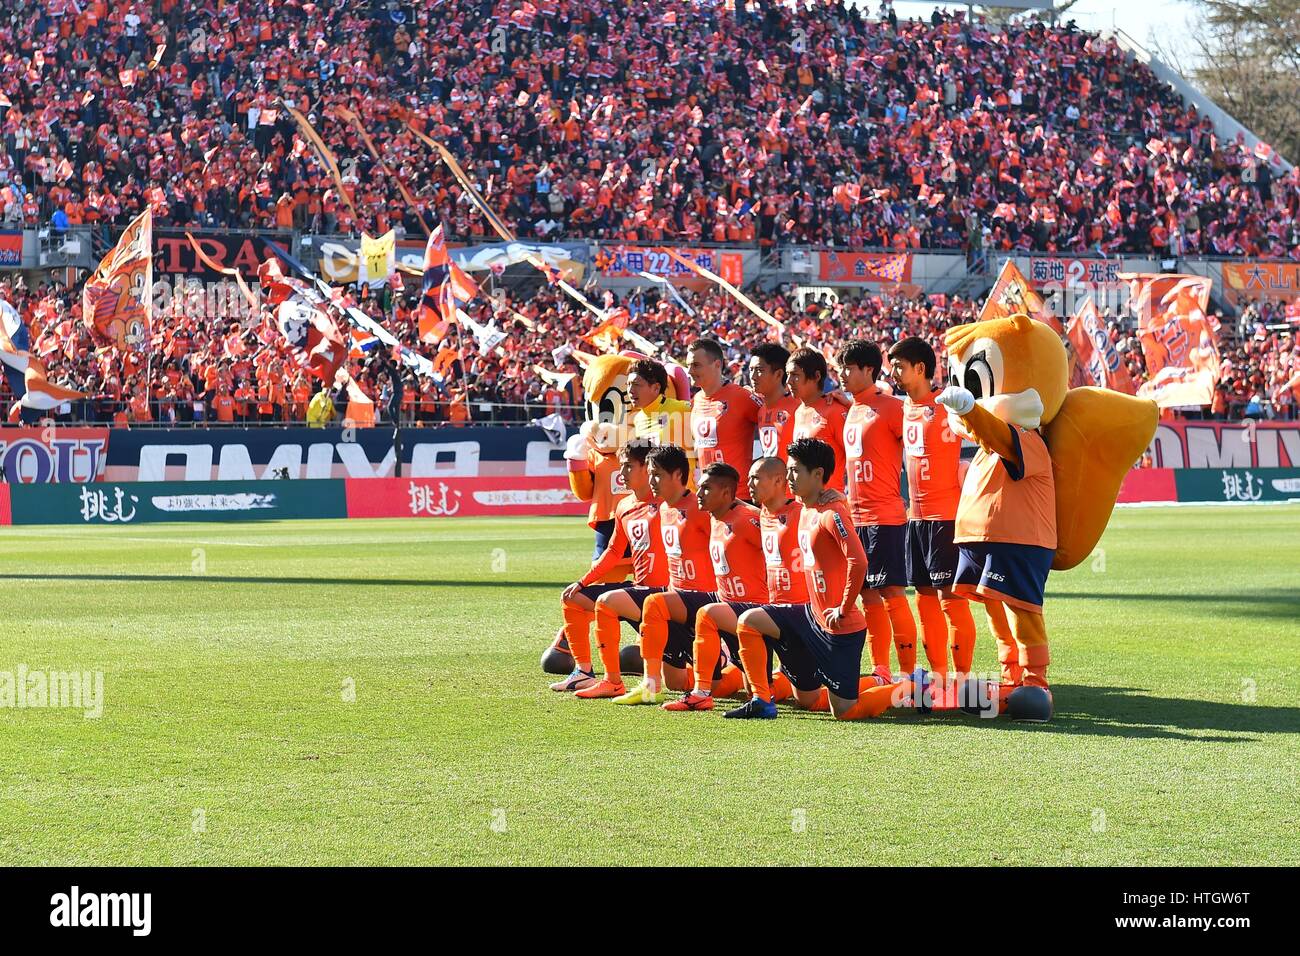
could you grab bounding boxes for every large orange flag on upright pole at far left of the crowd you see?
[82,207,153,351]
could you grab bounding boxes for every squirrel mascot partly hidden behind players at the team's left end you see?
[542,351,690,676]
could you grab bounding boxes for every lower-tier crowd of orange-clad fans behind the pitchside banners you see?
[0,267,1300,425]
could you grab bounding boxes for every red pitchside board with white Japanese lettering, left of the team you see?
[346,476,588,518]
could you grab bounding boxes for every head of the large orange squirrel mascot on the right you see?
[944,315,1069,438]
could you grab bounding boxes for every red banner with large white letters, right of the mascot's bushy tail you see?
[1149,421,1300,468]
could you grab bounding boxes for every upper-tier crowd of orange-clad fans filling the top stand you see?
[0,0,1300,256]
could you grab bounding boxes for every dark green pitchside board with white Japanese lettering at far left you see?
[9,481,347,524]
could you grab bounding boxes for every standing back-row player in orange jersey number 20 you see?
[836,339,917,676]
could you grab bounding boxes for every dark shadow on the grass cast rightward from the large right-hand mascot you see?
[930,684,1300,744]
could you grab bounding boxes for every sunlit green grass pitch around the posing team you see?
[0,505,1300,866]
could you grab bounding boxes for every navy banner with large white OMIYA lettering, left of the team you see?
[103,425,566,481]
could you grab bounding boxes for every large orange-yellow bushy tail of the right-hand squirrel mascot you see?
[1043,386,1160,571]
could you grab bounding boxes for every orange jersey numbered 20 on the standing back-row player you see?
[844,386,907,528]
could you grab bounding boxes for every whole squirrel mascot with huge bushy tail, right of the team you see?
[936,315,1158,721]
